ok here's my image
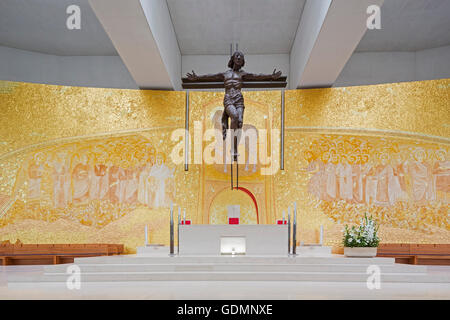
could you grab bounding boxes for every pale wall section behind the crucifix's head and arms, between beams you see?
[181,54,289,90]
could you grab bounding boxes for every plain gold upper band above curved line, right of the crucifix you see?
[285,79,450,138]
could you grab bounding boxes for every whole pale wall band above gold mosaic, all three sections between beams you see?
[0,46,450,90]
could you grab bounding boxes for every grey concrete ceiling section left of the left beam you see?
[0,0,117,56]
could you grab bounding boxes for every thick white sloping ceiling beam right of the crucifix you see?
[290,0,384,89]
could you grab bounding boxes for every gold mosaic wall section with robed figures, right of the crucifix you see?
[284,79,450,246]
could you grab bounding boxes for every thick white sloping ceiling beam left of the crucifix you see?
[89,0,181,90]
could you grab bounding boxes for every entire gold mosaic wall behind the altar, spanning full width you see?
[0,79,450,252]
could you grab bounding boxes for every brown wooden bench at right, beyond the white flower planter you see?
[377,243,450,265]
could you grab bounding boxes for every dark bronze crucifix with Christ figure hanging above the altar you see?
[181,51,286,190]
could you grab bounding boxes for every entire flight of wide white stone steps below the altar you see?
[8,255,450,286]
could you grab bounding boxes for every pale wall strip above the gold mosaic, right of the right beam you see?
[333,46,450,87]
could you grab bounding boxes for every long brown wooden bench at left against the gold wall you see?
[0,243,124,265]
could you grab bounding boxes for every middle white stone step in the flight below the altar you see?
[44,263,427,273]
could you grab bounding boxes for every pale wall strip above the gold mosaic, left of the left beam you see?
[0,46,138,89]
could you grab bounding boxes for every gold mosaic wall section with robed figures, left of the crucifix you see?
[0,82,186,252]
